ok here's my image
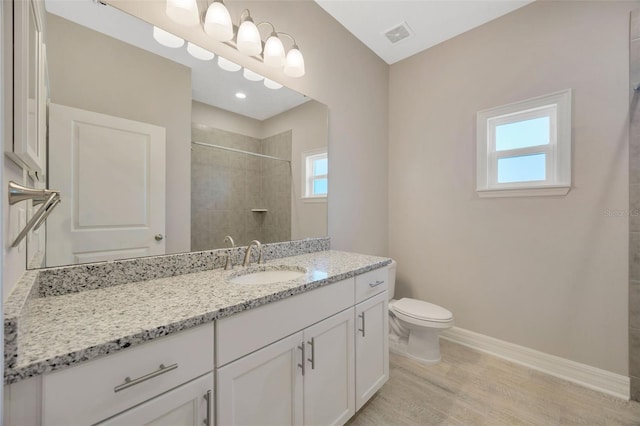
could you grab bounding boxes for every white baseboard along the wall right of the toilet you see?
[440,327,630,400]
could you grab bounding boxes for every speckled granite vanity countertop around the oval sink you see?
[5,250,391,383]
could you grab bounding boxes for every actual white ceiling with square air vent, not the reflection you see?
[315,0,533,64]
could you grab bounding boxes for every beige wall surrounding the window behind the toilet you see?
[389,1,639,375]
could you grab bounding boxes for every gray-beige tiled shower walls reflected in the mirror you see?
[191,123,291,251]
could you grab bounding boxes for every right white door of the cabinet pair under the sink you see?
[304,308,355,425]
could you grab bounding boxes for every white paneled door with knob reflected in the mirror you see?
[46,104,165,266]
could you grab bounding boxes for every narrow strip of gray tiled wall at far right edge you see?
[629,10,640,401]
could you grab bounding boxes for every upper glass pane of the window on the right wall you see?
[496,117,551,151]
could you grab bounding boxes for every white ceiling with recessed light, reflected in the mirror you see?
[45,0,310,121]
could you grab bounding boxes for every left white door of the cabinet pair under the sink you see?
[216,332,303,426]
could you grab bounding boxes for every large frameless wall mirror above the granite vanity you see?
[32,0,328,267]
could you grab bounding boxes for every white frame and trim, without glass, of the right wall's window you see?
[476,89,571,197]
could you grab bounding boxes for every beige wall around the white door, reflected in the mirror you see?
[47,14,191,253]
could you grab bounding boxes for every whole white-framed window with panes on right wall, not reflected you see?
[477,89,571,197]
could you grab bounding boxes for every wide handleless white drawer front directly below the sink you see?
[216,278,354,367]
